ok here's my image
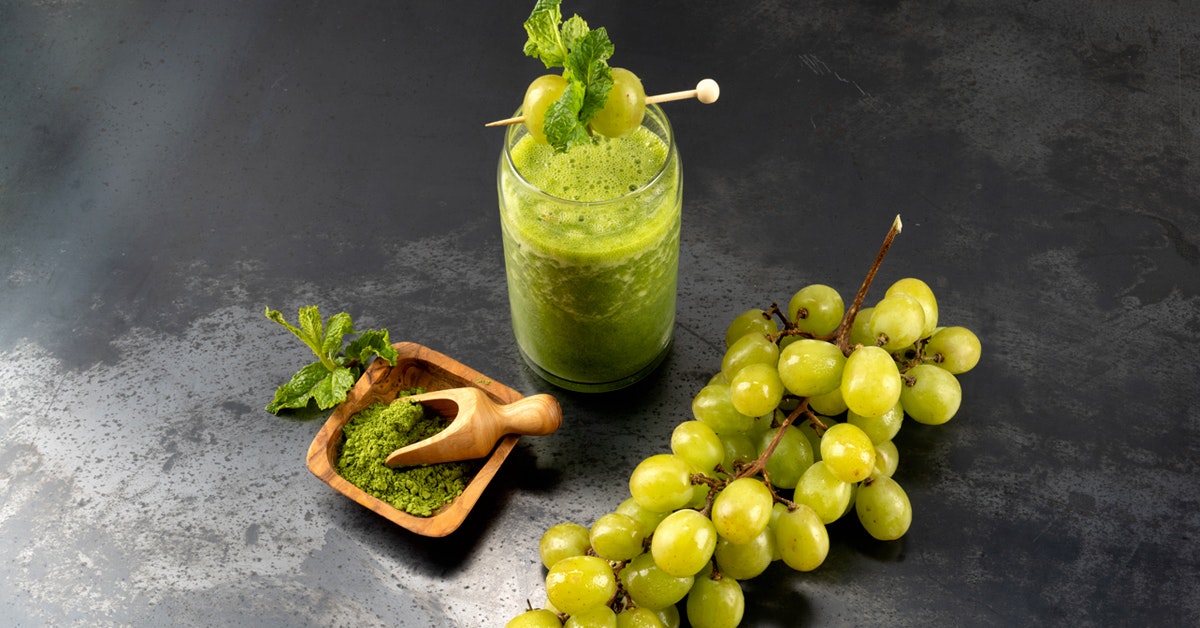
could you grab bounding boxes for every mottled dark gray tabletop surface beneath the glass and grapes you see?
[0,0,1200,627]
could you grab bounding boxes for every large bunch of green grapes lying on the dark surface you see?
[508,279,980,628]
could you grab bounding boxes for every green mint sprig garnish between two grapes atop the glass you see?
[524,0,613,152]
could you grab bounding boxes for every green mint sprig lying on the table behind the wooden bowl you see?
[265,305,397,414]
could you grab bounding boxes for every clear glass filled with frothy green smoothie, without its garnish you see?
[498,104,683,391]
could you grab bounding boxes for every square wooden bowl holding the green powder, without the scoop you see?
[307,342,522,537]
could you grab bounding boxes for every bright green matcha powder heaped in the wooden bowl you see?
[337,391,473,516]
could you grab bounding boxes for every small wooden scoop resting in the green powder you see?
[384,387,563,467]
